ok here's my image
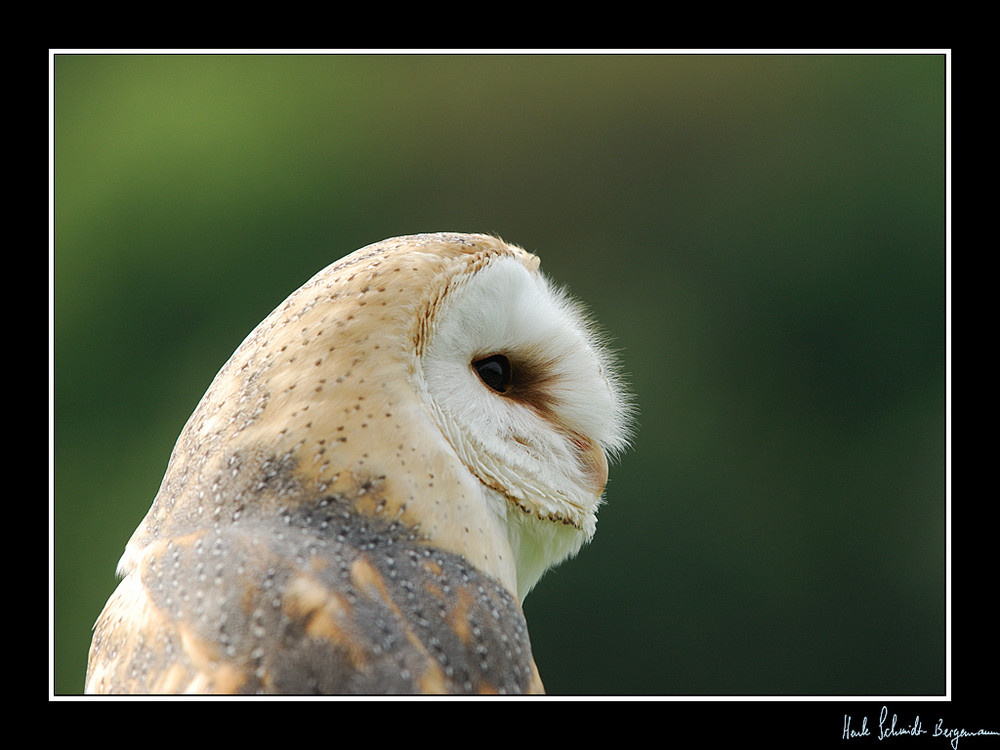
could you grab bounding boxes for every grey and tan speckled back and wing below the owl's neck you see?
[87,508,542,695]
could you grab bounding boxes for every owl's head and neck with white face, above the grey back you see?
[121,233,633,599]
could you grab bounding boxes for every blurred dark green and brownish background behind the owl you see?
[53,54,946,695]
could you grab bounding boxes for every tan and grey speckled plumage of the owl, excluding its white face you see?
[86,234,632,694]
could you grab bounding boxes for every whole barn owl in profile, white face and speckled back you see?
[85,233,632,694]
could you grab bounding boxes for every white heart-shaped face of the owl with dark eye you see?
[414,254,629,598]
